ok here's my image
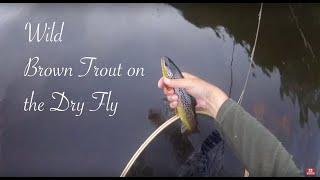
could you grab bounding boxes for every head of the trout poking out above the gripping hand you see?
[160,56,181,79]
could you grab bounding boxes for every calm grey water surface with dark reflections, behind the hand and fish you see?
[0,4,320,176]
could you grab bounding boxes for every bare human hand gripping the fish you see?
[158,72,228,118]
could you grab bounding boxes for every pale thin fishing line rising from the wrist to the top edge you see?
[238,3,263,104]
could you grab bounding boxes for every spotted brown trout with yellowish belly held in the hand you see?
[161,57,198,133]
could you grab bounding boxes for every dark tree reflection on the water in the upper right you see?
[174,4,320,127]
